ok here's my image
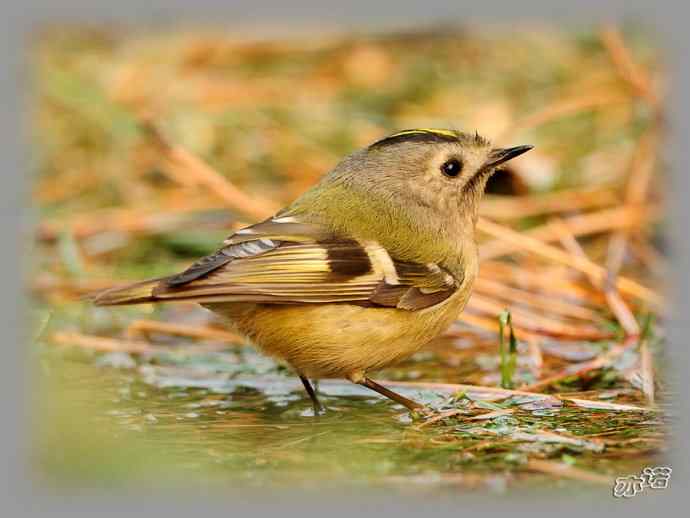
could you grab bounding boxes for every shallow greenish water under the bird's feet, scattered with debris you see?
[35,330,662,494]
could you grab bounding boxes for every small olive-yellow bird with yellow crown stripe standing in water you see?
[95,129,532,413]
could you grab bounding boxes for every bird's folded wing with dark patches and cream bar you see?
[97,217,462,311]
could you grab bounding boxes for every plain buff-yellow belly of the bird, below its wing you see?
[206,289,469,379]
